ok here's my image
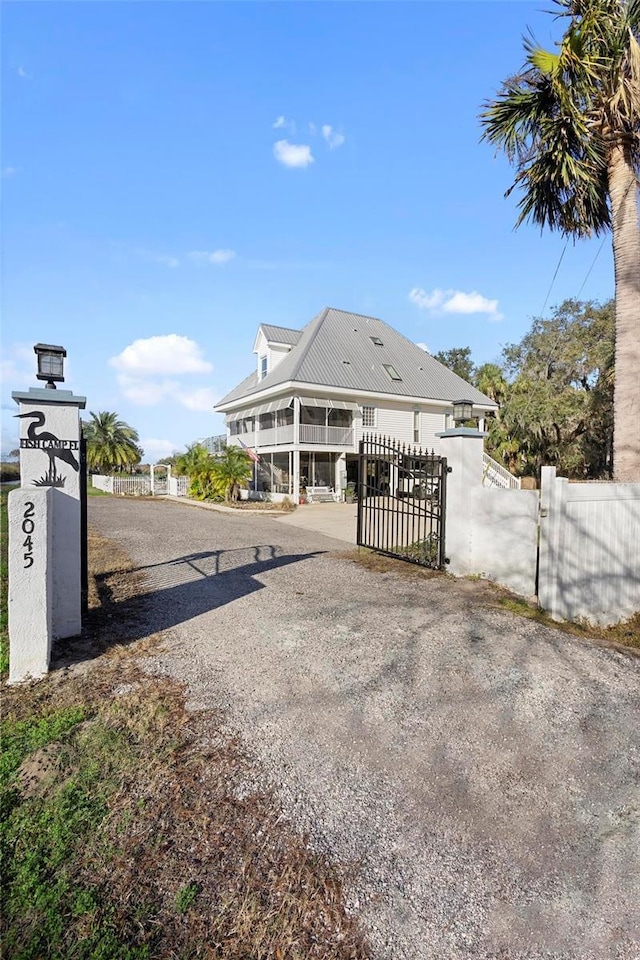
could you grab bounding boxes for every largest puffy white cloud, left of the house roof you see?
[109,333,212,377]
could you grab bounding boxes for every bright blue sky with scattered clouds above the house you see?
[2,0,613,460]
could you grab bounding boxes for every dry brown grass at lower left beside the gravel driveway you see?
[3,532,368,960]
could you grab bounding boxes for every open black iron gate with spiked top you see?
[357,436,448,569]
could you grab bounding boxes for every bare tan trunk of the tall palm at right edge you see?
[609,144,640,481]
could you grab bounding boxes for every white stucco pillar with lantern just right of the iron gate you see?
[436,427,484,576]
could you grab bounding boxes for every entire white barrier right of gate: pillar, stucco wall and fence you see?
[440,431,640,626]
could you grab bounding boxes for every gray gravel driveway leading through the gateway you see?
[89,498,640,960]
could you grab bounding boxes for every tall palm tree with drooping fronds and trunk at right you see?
[480,0,640,480]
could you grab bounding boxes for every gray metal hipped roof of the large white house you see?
[216,307,496,408]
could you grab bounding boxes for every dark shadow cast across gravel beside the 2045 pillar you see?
[51,544,325,670]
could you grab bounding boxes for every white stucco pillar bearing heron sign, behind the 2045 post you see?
[11,388,86,640]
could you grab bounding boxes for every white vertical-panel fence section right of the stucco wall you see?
[539,467,640,626]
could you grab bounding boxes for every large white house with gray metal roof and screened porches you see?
[215,307,497,503]
